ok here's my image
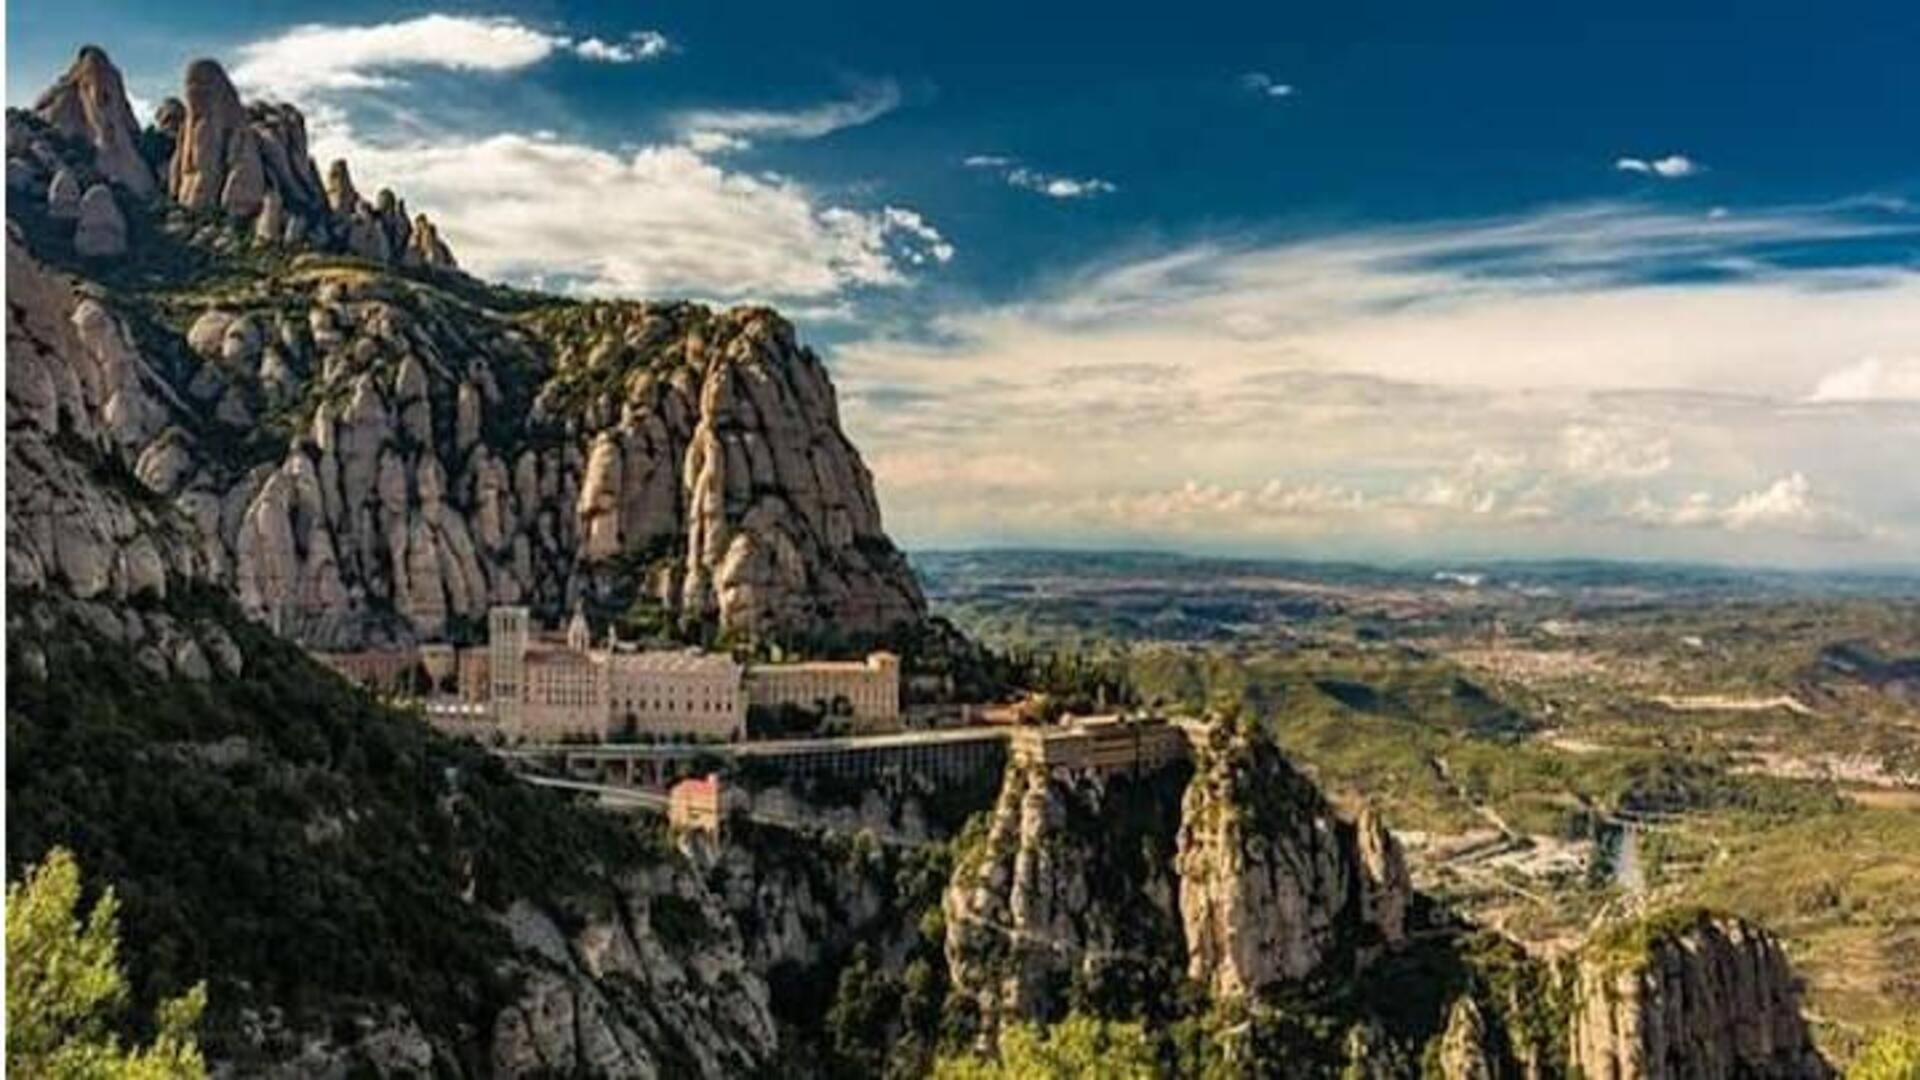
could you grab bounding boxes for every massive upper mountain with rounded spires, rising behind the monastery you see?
[8,46,925,648]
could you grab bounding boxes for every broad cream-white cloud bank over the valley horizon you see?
[831,196,1920,561]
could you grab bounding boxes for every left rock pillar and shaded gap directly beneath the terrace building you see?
[943,765,1187,1030]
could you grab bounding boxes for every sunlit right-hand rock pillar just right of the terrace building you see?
[1179,724,1409,999]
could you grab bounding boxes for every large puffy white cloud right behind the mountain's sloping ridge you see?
[313,121,954,302]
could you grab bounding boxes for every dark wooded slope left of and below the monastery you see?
[8,590,662,1059]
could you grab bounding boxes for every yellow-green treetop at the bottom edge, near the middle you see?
[933,1013,1162,1080]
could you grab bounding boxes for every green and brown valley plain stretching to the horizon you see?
[914,552,1920,1057]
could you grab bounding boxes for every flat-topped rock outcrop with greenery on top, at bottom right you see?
[1572,911,1830,1080]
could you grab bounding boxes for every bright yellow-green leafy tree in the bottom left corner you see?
[6,847,207,1080]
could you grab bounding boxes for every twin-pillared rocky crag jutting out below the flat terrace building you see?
[945,724,1411,1030]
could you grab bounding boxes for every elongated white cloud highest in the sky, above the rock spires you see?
[232,13,668,98]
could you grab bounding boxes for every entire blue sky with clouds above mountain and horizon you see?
[8,0,1920,567]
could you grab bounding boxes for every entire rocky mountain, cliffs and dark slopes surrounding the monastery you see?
[6,37,1822,1080]
